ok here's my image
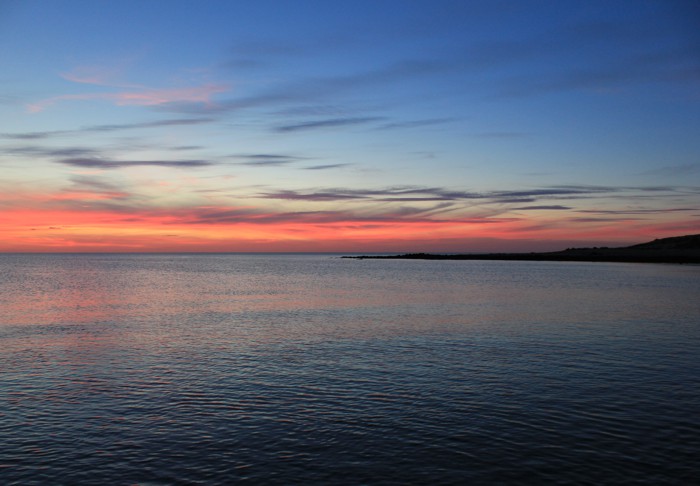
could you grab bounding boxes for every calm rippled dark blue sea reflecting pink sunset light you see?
[0,254,700,485]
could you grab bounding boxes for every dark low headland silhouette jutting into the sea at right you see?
[343,234,700,263]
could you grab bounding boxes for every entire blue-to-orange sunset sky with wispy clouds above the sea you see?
[0,0,700,253]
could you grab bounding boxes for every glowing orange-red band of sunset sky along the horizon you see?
[0,204,696,252]
